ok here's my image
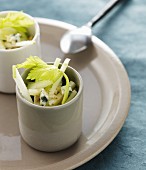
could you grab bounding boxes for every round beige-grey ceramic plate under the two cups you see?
[0,18,130,170]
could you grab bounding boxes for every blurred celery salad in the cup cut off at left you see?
[0,12,34,50]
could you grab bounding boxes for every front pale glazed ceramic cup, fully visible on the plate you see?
[16,63,83,152]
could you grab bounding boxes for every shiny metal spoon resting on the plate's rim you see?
[60,0,121,54]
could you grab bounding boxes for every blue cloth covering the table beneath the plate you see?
[0,0,146,170]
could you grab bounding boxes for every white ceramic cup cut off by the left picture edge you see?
[0,11,41,93]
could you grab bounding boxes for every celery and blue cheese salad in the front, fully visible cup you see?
[13,56,77,106]
